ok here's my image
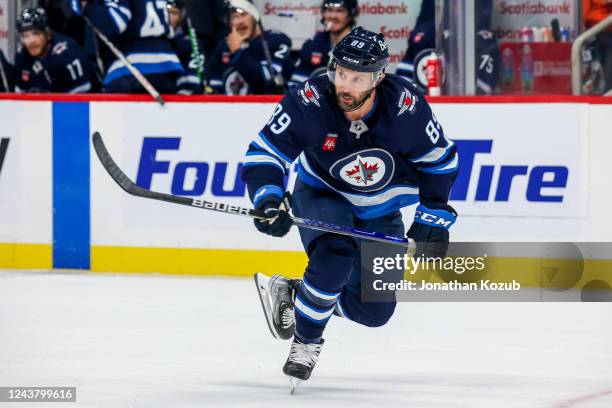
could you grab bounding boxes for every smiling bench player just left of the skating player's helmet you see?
[289,0,359,86]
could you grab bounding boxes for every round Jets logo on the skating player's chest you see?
[329,148,395,191]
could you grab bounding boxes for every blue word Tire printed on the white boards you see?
[450,140,569,203]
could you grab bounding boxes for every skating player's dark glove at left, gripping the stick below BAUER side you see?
[255,192,293,237]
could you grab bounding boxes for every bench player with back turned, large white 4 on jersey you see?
[82,0,183,93]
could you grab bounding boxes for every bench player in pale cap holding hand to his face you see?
[209,0,294,95]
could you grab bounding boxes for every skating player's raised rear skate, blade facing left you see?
[255,273,300,340]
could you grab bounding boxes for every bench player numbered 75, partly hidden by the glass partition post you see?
[395,0,500,95]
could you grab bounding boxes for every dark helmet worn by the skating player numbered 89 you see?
[329,27,389,72]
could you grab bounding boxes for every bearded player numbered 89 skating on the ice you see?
[242,27,458,390]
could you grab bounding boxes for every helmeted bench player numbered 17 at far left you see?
[15,8,94,93]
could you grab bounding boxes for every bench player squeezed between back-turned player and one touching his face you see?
[168,0,204,95]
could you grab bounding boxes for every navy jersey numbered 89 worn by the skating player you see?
[242,75,458,219]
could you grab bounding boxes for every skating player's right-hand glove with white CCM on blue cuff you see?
[406,204,457,258]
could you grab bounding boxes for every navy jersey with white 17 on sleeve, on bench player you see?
[15,33,94,93]
